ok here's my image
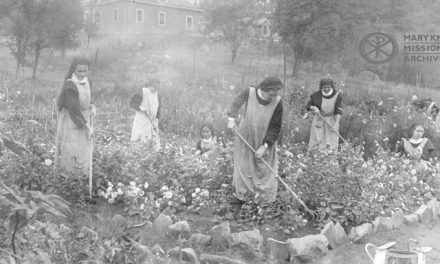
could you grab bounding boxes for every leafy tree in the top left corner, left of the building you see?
[0,0,82,79]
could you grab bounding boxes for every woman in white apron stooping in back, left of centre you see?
[130,78,160,151]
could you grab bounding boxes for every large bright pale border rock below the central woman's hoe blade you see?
[286,234,328,262]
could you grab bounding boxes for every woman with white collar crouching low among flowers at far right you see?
[399,124,435,172]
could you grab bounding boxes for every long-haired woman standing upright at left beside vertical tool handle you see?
[55,57,96,174]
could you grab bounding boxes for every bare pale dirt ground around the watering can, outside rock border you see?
[315,222,440,264]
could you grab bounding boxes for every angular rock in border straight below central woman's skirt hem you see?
[230,229,264,259]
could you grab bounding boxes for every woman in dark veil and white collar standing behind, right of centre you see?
[306,78,342,151]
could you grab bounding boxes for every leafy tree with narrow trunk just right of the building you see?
[201,0,255,63]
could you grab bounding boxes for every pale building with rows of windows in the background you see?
[82,0,203,38]
